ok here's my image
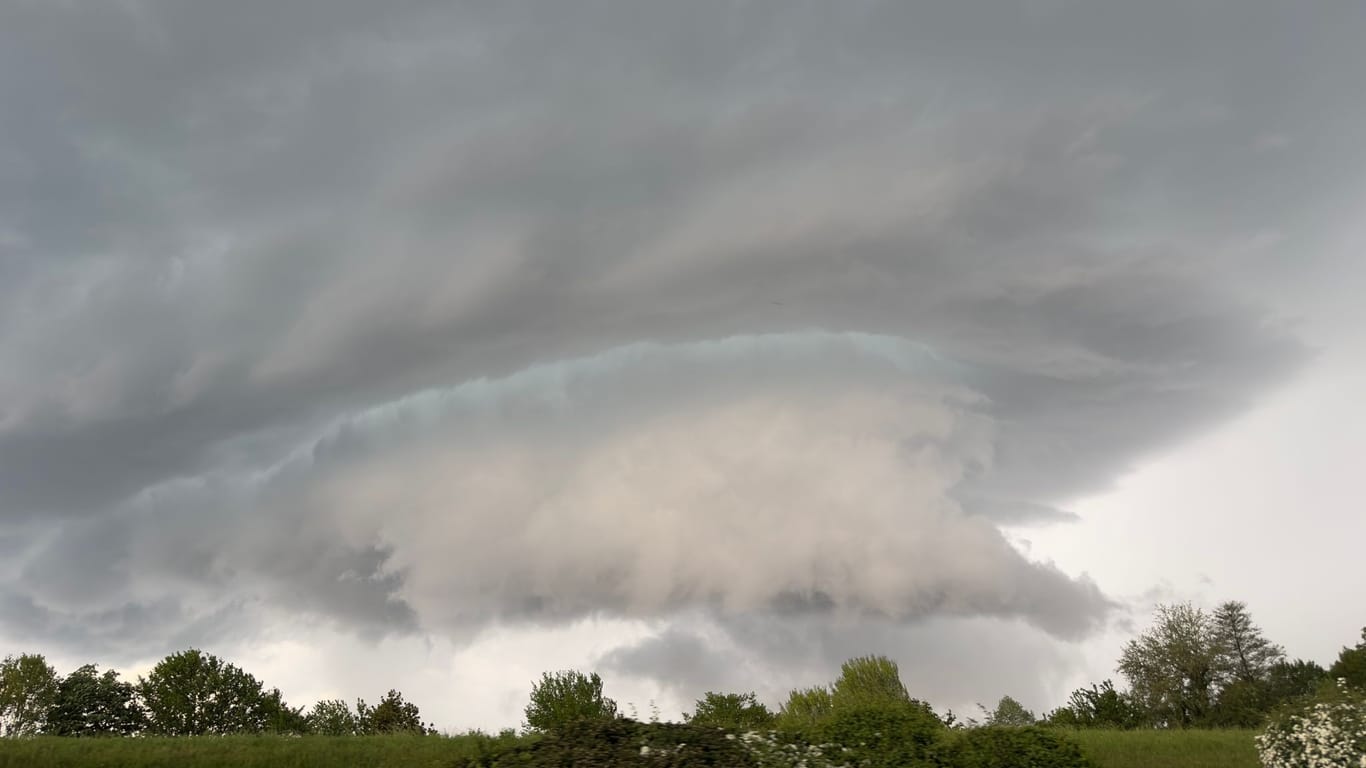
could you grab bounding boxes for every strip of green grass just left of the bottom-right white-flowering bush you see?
[1067,730,1261,768]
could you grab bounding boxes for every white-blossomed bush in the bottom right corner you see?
[1257,681,1366,768]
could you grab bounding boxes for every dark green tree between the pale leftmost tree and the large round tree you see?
[46,664,148,737]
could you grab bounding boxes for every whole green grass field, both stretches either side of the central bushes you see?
[0,731,1259,768]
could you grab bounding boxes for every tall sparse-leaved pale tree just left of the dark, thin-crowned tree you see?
[1119,603,1225,728]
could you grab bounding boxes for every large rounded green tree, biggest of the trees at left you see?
[138,648,285,737]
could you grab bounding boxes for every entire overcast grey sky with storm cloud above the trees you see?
[0,0,1366,730]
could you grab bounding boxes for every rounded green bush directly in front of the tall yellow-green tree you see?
[811,702,949,768]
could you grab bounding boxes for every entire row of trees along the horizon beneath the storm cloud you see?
[0,601,1366,737]
